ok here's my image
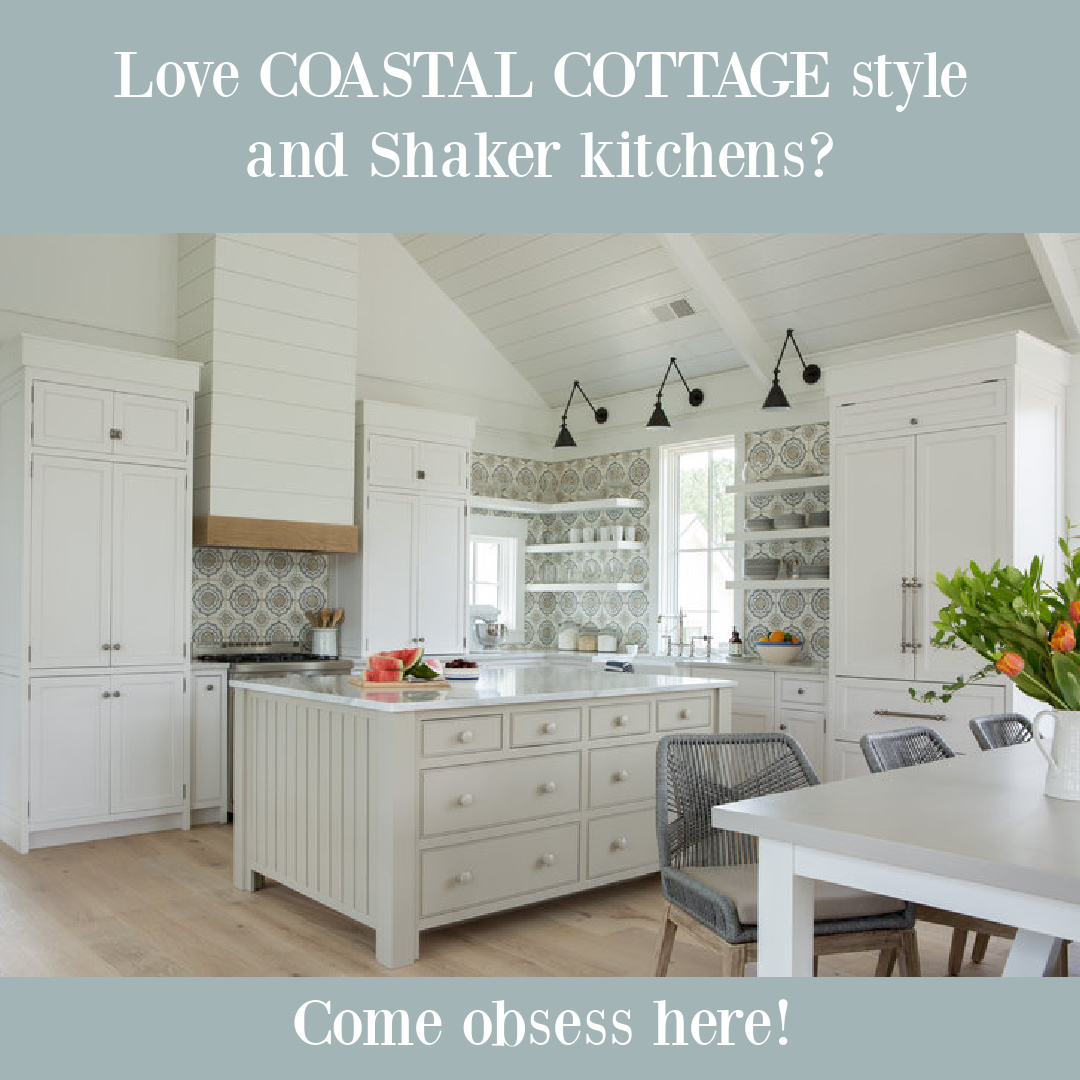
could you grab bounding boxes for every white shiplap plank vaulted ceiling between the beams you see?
[397,233,1050,406]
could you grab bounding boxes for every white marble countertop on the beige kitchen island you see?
[230,664,735,713]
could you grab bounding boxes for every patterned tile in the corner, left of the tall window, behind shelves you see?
[471,450,656,649]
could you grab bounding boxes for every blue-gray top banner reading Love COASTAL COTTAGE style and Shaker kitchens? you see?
[0,0,1080,231]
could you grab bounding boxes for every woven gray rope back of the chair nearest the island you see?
[657,732,820,867]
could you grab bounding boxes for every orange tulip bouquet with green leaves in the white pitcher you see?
[910,523,1080,711]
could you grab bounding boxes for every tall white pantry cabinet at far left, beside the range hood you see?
[0,335,199,851]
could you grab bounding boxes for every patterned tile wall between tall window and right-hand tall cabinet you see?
[743,423,829,663]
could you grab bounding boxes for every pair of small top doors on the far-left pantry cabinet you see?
[30,379,190,462]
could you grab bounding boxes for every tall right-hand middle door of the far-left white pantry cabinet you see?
[110,464,191,666]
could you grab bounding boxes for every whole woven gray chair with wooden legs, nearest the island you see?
[656,733,919,975]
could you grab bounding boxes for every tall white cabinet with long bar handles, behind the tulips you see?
[828,334,1068,779]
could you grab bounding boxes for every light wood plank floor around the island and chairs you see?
[0,826,1062,976]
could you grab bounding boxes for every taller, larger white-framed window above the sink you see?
[661,440,741,642]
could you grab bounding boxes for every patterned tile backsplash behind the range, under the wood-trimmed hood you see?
[191,548,329,646]
